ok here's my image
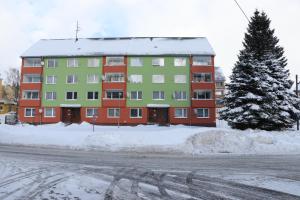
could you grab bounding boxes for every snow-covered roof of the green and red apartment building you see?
[21,37,215,57]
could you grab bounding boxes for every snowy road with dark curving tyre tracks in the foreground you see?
[0,145,300,200]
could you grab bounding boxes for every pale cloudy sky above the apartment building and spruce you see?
[0,0,300,82]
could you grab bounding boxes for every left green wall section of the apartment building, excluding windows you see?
[42,57,102,107]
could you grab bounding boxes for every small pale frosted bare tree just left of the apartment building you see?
[5,68,20,101]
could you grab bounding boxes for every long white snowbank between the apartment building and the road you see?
[0,123,300,154]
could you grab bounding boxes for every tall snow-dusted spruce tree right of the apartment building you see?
[220,10,300,130]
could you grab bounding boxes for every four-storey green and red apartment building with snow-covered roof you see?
[18,37,216,126]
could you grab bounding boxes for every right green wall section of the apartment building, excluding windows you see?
[126,56,190,107]
